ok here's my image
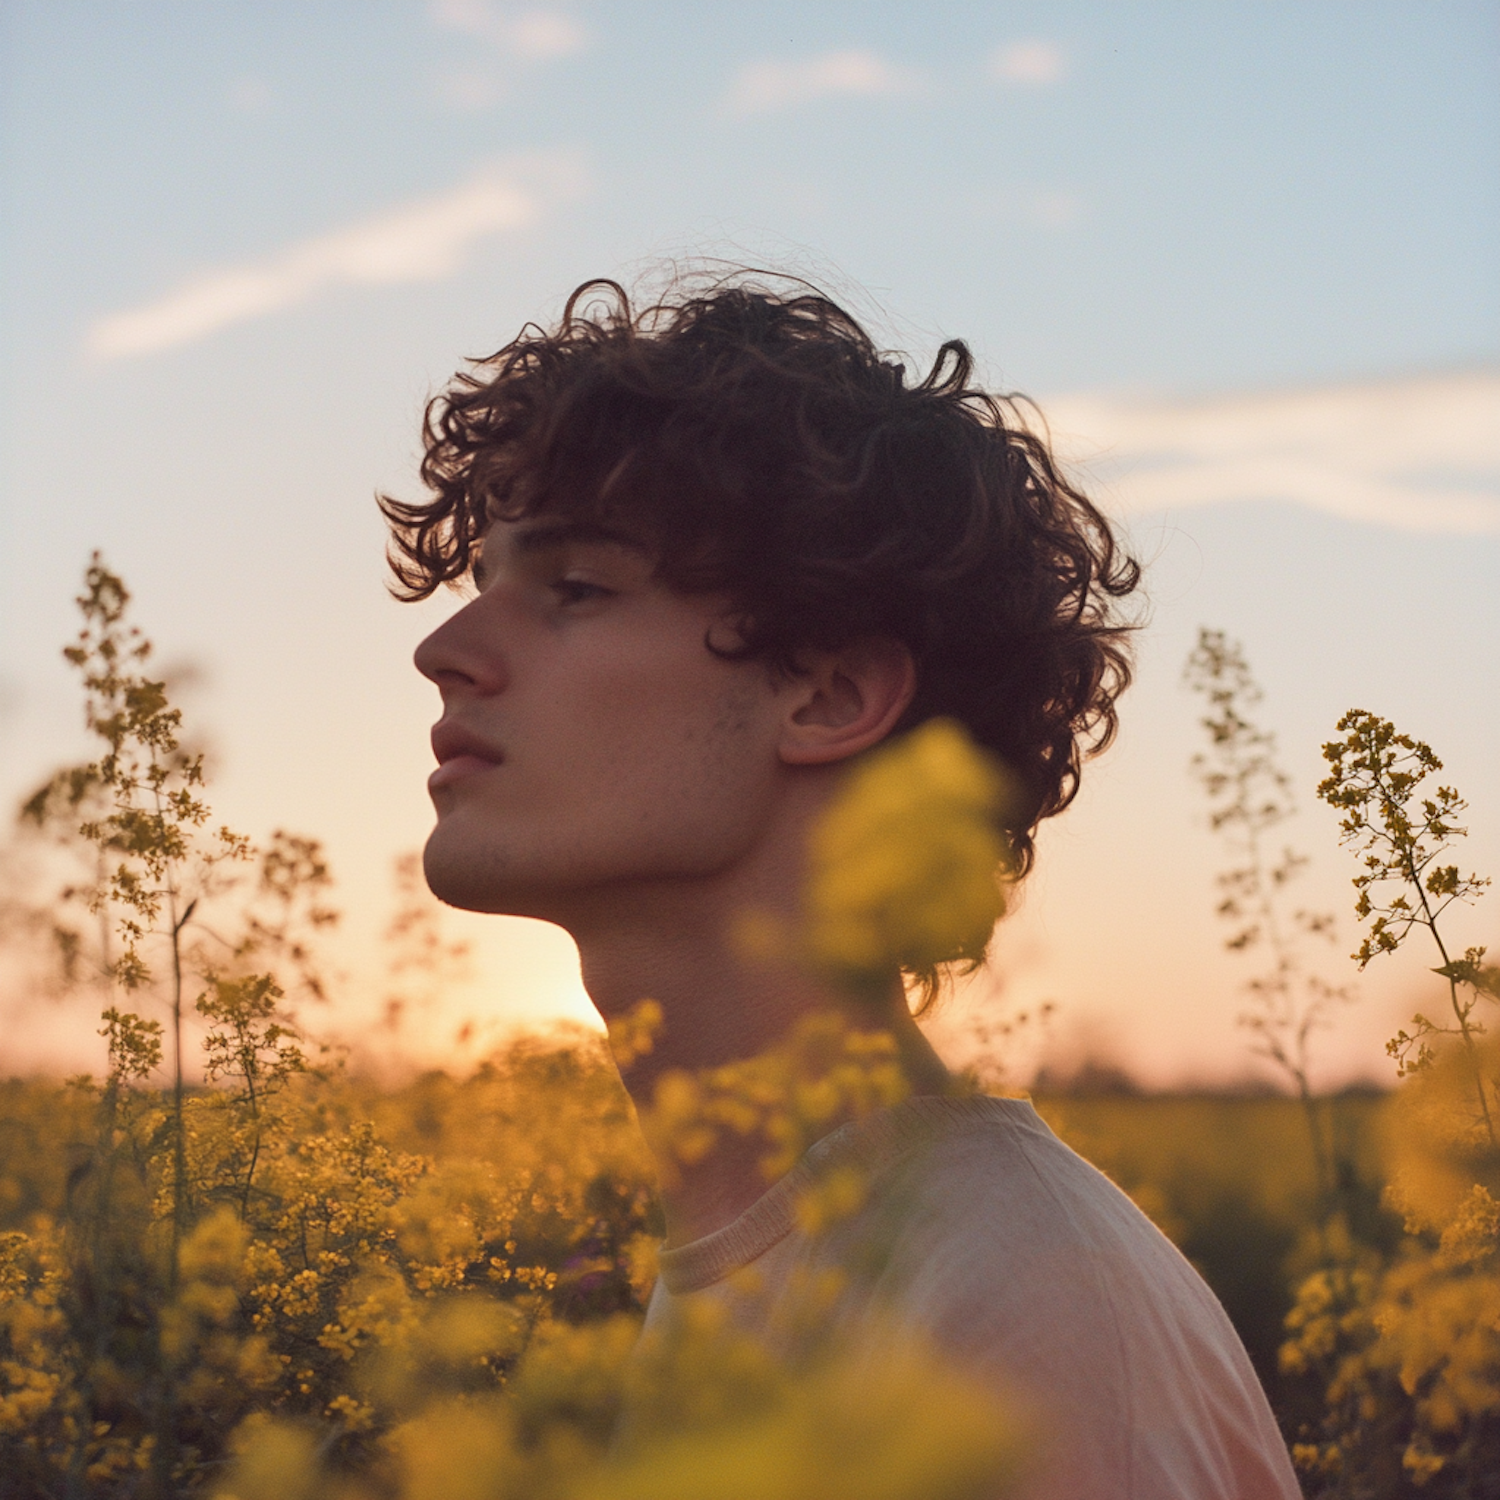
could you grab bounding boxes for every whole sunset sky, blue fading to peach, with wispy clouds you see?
[0,0,1500,1085]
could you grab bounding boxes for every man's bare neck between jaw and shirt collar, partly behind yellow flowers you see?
[570,872,951,1245]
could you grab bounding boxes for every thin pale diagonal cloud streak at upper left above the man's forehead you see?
[87,153,582,360]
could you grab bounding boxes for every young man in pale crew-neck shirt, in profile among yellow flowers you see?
[384,278,1298,1500]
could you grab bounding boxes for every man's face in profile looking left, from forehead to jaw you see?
[416,518,779,921]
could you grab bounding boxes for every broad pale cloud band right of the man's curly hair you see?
[1044,371,1500,534]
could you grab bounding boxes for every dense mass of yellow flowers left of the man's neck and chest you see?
[0,1035,656,1500]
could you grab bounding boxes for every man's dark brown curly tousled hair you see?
[380,273,1140,875]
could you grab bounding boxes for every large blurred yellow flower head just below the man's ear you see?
[807,719,1010,984]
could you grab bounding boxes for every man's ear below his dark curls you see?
[777,636,917,765]
